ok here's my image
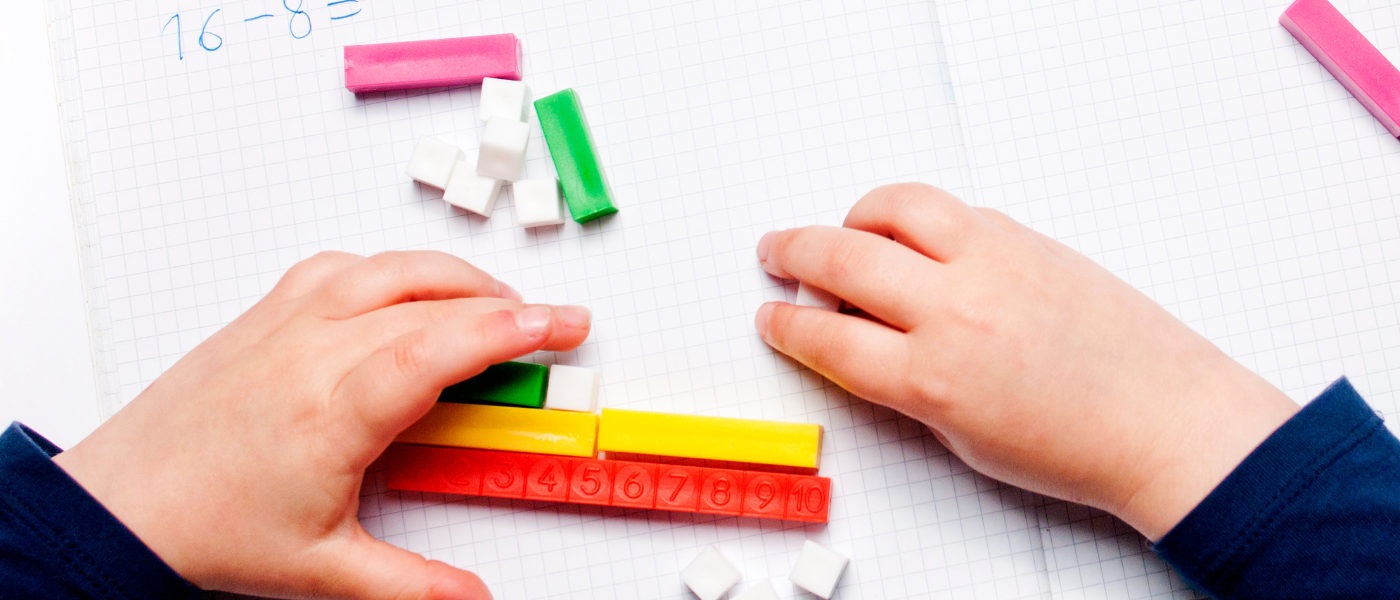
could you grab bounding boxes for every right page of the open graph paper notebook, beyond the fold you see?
[938,0,1400,599]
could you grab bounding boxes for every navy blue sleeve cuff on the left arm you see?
[0,422,199,600]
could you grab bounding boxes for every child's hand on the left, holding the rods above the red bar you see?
[55,252,589,599]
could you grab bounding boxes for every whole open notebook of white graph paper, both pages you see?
[32,0,1400,599]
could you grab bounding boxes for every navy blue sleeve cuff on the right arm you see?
[1154,379,1400,600]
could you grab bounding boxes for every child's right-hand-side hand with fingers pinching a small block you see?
[756,185,1298,540]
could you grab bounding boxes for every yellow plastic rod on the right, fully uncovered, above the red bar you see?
[598,408,822,469]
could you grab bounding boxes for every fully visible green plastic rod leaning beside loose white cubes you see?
[535,90,617,222]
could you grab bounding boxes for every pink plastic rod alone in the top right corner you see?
[1278,0,1400,137]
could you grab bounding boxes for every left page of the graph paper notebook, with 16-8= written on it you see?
[43,0,1049,599]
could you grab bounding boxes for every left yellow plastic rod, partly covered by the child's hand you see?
[396,401,598,455]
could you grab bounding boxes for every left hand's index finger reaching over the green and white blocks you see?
[336,306,591,439]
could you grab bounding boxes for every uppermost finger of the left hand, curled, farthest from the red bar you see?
[318,252,519,319]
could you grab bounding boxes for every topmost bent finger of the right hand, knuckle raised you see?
[846,183,987,263]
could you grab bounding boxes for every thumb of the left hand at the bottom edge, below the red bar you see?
[326,530,491,600]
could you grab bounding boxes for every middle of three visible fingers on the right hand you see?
[759,227,942,331]
